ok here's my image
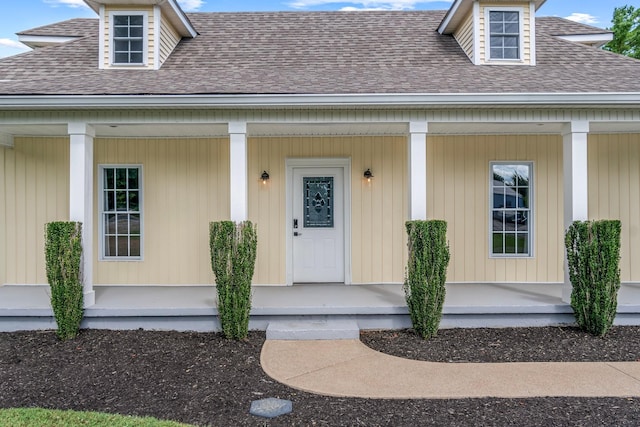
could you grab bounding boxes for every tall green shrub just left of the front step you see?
[209,221,258,340]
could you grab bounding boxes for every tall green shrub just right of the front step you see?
[404,220,449,339]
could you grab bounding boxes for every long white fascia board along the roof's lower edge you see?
[0,92,640,110]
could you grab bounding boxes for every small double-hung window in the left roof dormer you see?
[111,14,145,65]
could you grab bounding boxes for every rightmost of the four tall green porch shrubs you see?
[565,220,621,336]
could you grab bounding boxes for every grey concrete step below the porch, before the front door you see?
[267,319,360,340]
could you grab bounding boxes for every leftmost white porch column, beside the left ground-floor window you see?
[69,123,96,307]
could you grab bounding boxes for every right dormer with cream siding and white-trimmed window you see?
[438,0,546,65]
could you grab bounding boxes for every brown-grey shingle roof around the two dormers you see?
[0,11,640,95]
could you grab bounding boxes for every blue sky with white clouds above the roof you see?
[0,0,640,57]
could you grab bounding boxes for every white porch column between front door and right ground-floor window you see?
[408,122,429,220]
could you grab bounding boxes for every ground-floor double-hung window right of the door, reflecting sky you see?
[490,162,533,257]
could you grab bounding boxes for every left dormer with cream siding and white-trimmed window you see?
[85,0,197,70]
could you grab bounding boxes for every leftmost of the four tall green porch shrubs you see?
[45,222,83,340]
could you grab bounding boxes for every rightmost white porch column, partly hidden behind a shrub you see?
[562,121,589,303]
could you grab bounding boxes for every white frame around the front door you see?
[284,157,351,286]
